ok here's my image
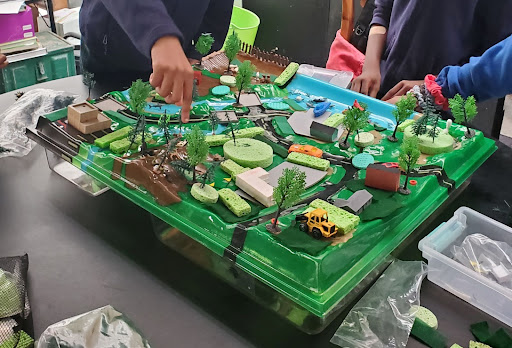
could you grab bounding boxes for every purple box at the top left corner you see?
[0,6,34,43]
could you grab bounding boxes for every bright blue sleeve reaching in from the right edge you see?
[436,36,512,101]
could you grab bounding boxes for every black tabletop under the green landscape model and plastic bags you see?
[0,76,512,347]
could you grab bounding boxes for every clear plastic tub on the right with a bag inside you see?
[418,207,512,326]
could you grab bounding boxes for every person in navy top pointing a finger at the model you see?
[80,0,233,122]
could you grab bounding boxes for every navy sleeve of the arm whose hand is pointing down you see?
[102,0,183,58]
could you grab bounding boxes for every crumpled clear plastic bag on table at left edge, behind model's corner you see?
[0,89,78,158]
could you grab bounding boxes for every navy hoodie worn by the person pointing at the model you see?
[80,0,233,78]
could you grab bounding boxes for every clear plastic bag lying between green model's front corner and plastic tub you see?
[331,261,427,348]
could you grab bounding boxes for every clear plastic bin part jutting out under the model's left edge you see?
[45,149,109,196]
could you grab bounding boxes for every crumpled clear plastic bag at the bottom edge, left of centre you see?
[35,305,151,348]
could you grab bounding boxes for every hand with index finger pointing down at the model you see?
[149,36,194,123]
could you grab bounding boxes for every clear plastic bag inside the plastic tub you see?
[452,233,512,289]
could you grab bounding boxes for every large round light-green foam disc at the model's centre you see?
[223,138,274,168]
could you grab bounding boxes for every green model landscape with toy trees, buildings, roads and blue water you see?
[28,35,495,326]
